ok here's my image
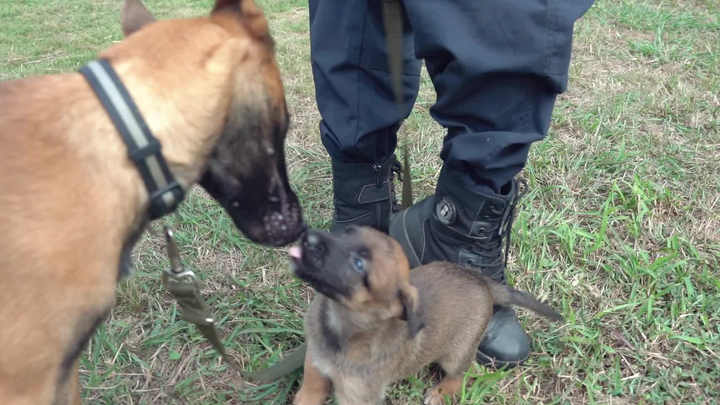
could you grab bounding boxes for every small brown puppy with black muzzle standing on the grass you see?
[291,227,562,405]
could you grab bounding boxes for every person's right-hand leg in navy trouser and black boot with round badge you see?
[390,0,593,366]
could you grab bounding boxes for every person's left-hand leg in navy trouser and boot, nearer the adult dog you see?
[309,0,421,232]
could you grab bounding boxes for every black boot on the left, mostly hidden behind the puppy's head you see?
[330,156,399,237]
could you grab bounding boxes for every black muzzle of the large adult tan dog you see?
[199,96,307,246]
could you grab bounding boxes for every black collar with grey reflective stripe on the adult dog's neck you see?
[80,59,185,220]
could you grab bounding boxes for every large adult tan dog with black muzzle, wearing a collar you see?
[0,0,305,405]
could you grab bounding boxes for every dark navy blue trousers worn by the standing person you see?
[309,0,593,193]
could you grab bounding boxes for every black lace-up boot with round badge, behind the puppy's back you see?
[390,163,530,367]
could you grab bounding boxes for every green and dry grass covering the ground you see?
[0,0,720,405]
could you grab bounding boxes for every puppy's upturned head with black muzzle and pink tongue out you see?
[290,226,424,338]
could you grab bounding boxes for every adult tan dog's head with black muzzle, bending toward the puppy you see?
[118,0,306,246]
